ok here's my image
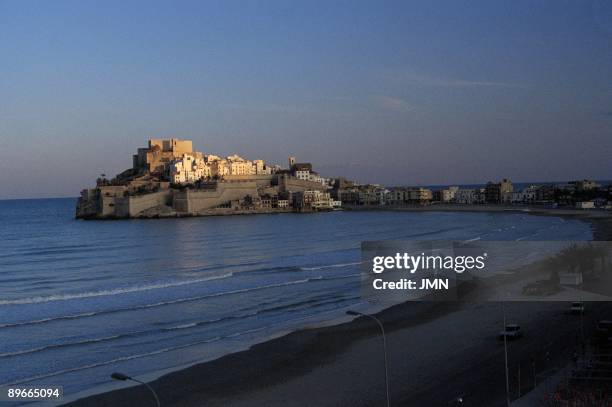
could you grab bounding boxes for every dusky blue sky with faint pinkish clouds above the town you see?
[0,0,612,199]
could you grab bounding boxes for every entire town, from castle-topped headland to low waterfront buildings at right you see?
[76,138,612,219]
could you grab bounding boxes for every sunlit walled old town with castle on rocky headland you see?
[76,138,340,219]
